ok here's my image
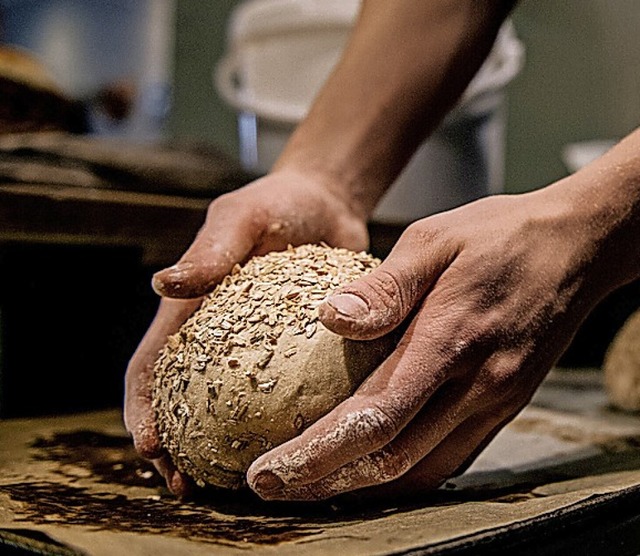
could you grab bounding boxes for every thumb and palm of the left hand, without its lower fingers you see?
[153,171,368,298]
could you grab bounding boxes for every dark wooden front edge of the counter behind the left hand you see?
[0,184,209,266]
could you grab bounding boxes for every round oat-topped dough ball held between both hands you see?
[153,245,394,488]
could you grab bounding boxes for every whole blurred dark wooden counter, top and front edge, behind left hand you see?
[0,133,254,266]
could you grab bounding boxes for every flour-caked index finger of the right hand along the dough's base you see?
[247,294,482,496]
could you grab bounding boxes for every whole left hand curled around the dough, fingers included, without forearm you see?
[125,171,368,497]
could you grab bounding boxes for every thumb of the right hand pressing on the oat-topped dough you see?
[319,220,458,340]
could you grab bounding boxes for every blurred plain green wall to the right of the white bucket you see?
[507,0,640,191]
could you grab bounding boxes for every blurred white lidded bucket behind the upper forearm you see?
[215,0,524,224]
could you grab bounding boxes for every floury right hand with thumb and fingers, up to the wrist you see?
[248,186,598,500]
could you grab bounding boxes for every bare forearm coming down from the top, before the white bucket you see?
[275,0,514,217]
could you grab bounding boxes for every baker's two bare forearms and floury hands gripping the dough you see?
[126,0,640,499]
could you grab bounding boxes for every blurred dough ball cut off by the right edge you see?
[603,311,640,411]
